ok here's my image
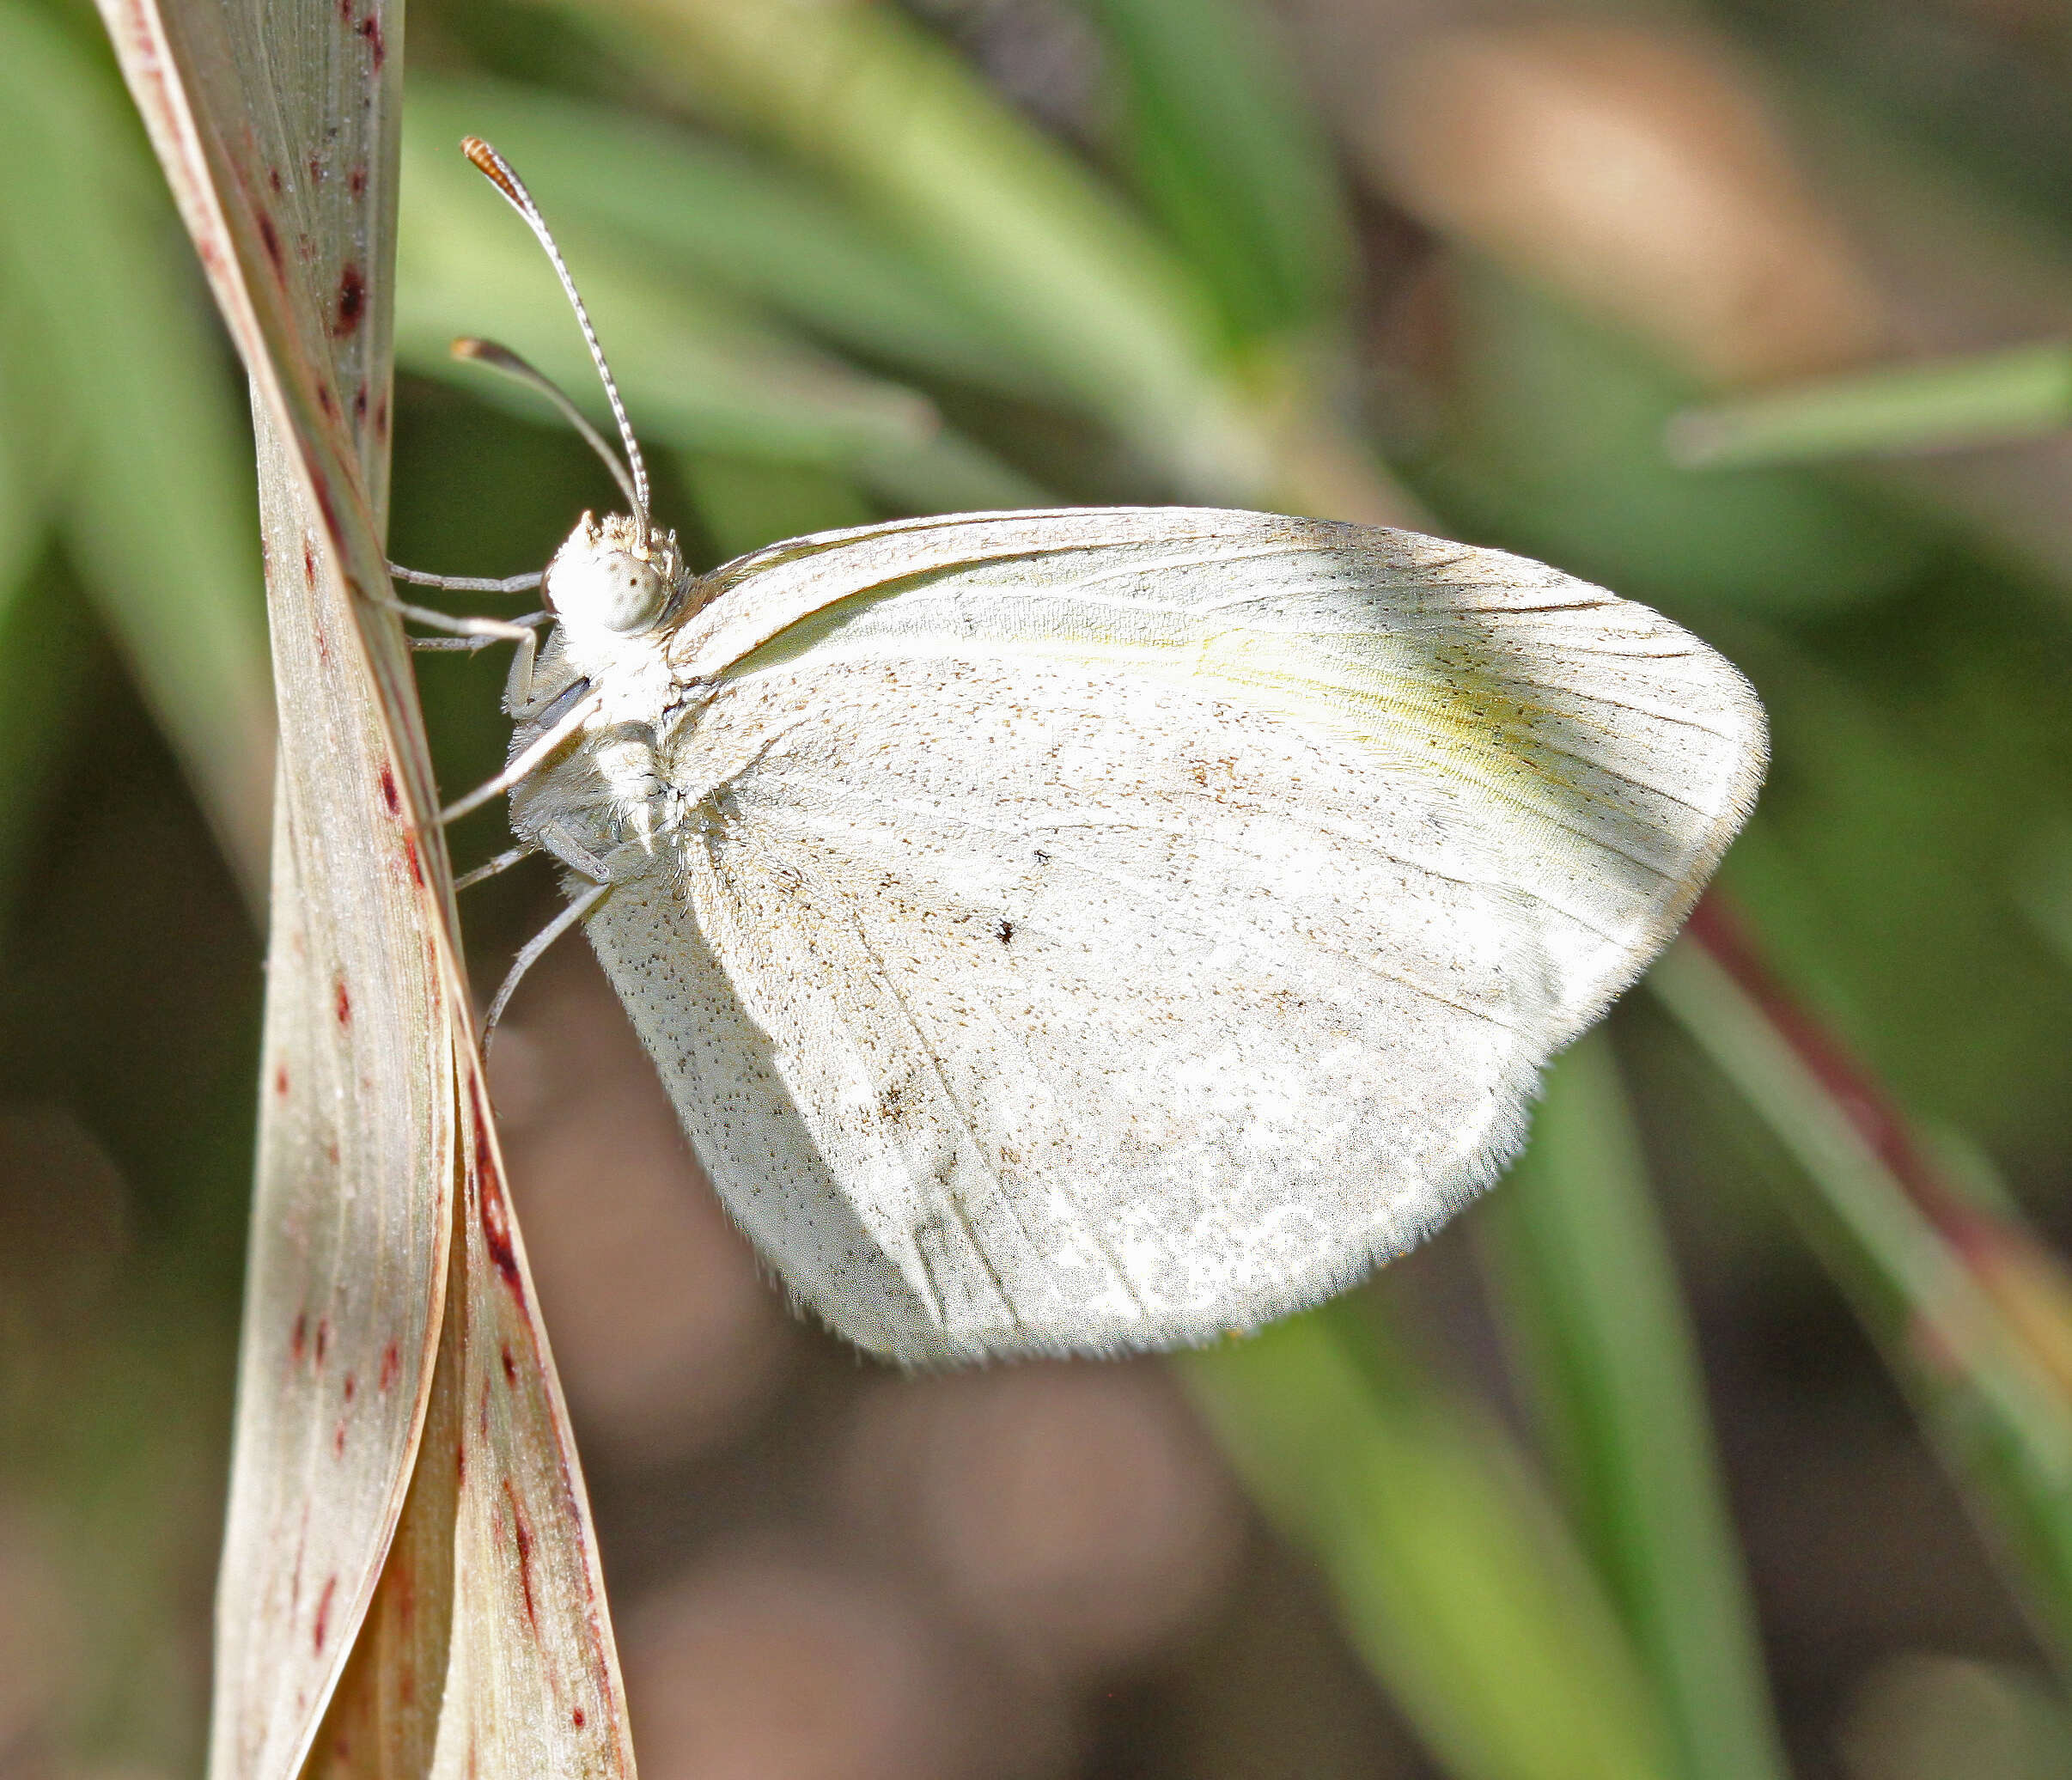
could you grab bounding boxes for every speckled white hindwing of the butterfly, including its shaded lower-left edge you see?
[590,661,1545,1359]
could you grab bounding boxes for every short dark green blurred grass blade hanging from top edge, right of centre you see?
[1082,0,1353,342]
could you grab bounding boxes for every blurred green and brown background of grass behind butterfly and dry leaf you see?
[12,0,2072,1780]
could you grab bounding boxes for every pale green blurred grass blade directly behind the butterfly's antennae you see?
[396,120,1042,508]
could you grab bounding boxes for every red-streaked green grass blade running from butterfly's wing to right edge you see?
[1648,904,2072,1673]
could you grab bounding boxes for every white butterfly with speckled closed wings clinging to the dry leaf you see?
[408,145,1765,1362]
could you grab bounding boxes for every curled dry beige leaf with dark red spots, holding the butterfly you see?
[88,0,632,1780]
